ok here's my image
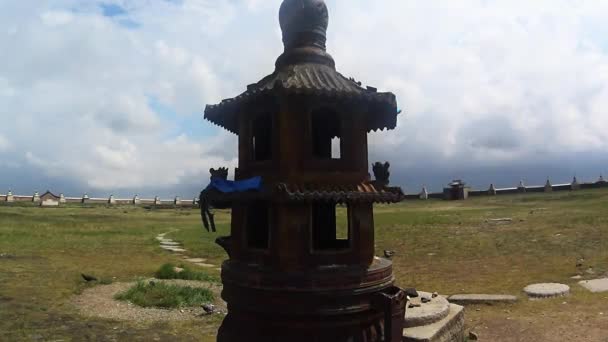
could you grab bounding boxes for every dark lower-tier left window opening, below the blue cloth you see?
[246,201,270,249]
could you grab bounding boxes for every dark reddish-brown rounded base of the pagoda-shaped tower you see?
[217,260,396,342]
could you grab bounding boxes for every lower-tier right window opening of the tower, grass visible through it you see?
[312,203,350,251]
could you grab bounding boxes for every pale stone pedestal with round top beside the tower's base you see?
[402,292,464,342]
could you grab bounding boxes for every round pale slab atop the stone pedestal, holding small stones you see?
[403,291,450,328]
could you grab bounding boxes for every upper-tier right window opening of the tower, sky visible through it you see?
[311,109,342,159]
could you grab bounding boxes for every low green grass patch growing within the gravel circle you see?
[114,281,214,309]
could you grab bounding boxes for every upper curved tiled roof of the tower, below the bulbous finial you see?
[205,63,398,133]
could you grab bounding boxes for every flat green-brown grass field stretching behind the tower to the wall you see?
[0,190,608,342]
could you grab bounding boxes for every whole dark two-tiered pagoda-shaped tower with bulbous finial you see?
[201,0,406,342]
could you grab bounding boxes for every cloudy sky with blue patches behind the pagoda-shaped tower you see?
[0,0,608,197]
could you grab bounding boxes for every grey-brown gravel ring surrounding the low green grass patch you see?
[71,279,226,322]
